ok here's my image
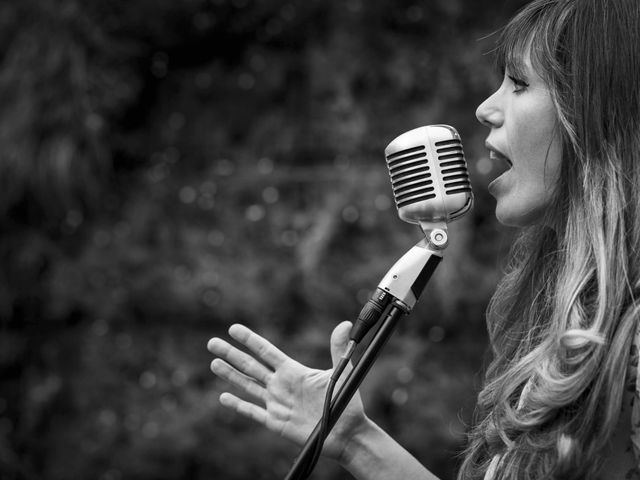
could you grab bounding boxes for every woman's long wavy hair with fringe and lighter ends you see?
[458,0,640,480]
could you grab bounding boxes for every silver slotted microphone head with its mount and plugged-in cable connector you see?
[351,125,473,342]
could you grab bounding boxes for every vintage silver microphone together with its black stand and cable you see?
[285,125,473,480]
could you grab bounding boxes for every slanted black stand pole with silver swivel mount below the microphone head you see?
[285,227,447,480]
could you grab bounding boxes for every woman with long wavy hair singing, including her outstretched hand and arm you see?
[209,0,640,479]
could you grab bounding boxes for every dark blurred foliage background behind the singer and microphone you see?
[0,0,524,480]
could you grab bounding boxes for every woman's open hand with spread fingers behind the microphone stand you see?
[207,322,367,461]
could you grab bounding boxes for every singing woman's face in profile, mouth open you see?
[476,51,562,227]
